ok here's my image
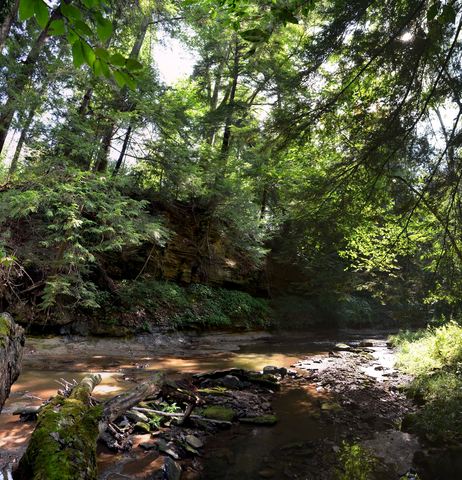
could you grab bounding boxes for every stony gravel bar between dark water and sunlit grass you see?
[293,340,419,480]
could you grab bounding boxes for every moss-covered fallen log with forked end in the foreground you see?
[14,375,163,480]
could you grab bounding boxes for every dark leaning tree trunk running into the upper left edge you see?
[0,8,61,152]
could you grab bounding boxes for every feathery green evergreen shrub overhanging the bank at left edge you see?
[0,169,169,311]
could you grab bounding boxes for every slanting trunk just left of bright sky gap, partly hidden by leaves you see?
[94,15,151,172]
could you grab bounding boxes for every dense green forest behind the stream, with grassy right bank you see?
[0,0,462,480]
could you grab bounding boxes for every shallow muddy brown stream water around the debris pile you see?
[0,332,398,480]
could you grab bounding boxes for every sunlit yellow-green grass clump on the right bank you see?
[391,321,462,442]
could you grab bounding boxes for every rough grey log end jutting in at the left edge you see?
[0,313,24,412]
